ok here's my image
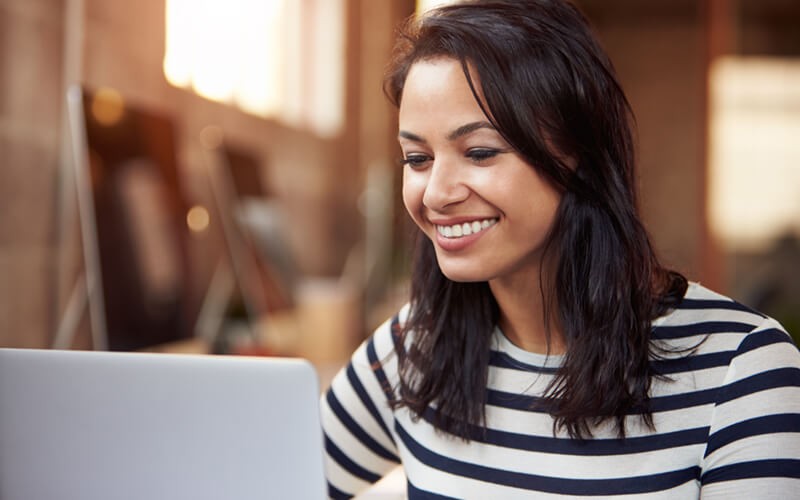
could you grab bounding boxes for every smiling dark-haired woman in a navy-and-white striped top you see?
[322,0,800,499]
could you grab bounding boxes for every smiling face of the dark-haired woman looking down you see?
[399,58,560,282]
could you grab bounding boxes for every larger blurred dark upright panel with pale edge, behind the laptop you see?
[53,85,195,350]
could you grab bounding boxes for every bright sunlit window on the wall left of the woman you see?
[164,0,346,137]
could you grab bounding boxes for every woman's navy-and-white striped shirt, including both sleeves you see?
[322,283,800,499]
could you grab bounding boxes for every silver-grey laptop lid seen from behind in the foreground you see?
[0,349,327,500]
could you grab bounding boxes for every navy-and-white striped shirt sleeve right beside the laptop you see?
[320,314,400,499]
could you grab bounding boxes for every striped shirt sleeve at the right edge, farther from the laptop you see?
[700,318,800,499]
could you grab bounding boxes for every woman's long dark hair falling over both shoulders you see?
[384,0,687,439]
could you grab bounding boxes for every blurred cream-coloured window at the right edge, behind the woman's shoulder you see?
[709,56,800,250]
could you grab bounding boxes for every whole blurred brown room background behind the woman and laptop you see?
[0,0,800,366]
